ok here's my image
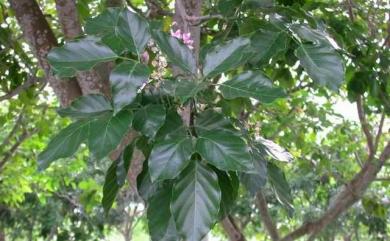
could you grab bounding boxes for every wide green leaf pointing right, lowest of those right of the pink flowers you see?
[220,71,286,103]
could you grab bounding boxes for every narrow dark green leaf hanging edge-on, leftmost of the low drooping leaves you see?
[102,160,120,214]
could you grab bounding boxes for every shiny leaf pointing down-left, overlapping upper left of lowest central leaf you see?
[149,136,193,182]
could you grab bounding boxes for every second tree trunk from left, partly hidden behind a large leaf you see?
[56,0,110,97]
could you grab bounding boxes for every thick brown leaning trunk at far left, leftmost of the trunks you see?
[9,0,81,106]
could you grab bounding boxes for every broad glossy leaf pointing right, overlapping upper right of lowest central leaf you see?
[195,130,253,172]
